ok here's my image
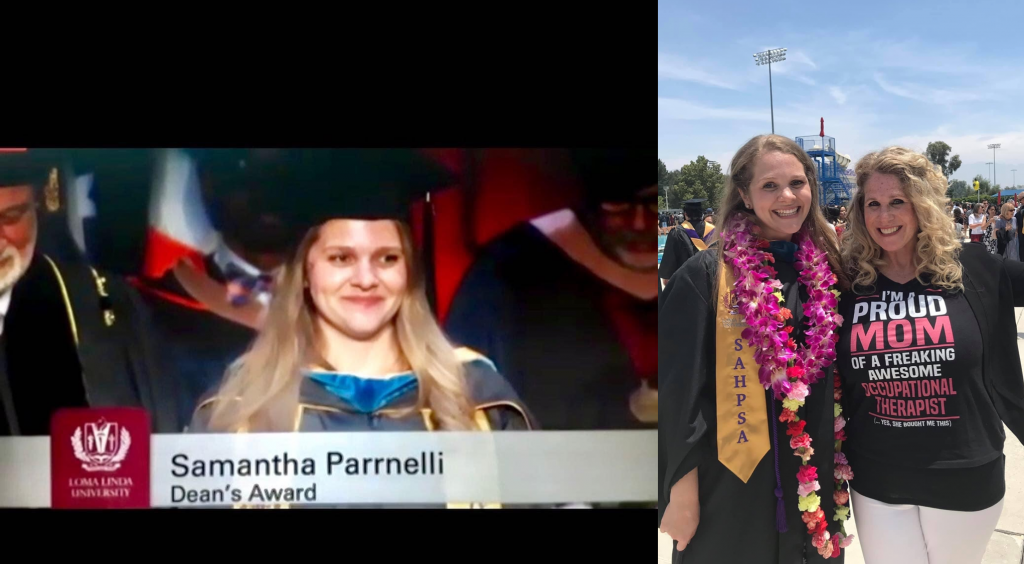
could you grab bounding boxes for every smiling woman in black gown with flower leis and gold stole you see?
[658,135,852,564]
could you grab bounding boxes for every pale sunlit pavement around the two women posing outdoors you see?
[657,298,1024,564]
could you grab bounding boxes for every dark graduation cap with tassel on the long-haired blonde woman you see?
[189,148,456,305]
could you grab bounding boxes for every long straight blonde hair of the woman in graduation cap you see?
[209,221,475,432]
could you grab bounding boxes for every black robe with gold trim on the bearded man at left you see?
[0,253,176,436]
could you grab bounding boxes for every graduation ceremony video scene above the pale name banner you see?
[0,148,658,485]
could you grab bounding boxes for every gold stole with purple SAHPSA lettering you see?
[715,264,770,483]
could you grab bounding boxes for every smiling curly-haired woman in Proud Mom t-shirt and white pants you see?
[836,147,1024,564]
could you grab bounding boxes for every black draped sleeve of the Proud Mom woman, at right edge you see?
[983,260,1024,440]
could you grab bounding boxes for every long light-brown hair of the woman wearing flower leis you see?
[713,135,846,309]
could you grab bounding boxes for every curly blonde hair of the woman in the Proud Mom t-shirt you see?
[842,146,964,292]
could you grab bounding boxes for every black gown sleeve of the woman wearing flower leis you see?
[657,251,718,523]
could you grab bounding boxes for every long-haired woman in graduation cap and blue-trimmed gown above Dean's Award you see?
[189,149,534,507]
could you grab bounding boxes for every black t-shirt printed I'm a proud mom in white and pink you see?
[837,274,1003,511]
